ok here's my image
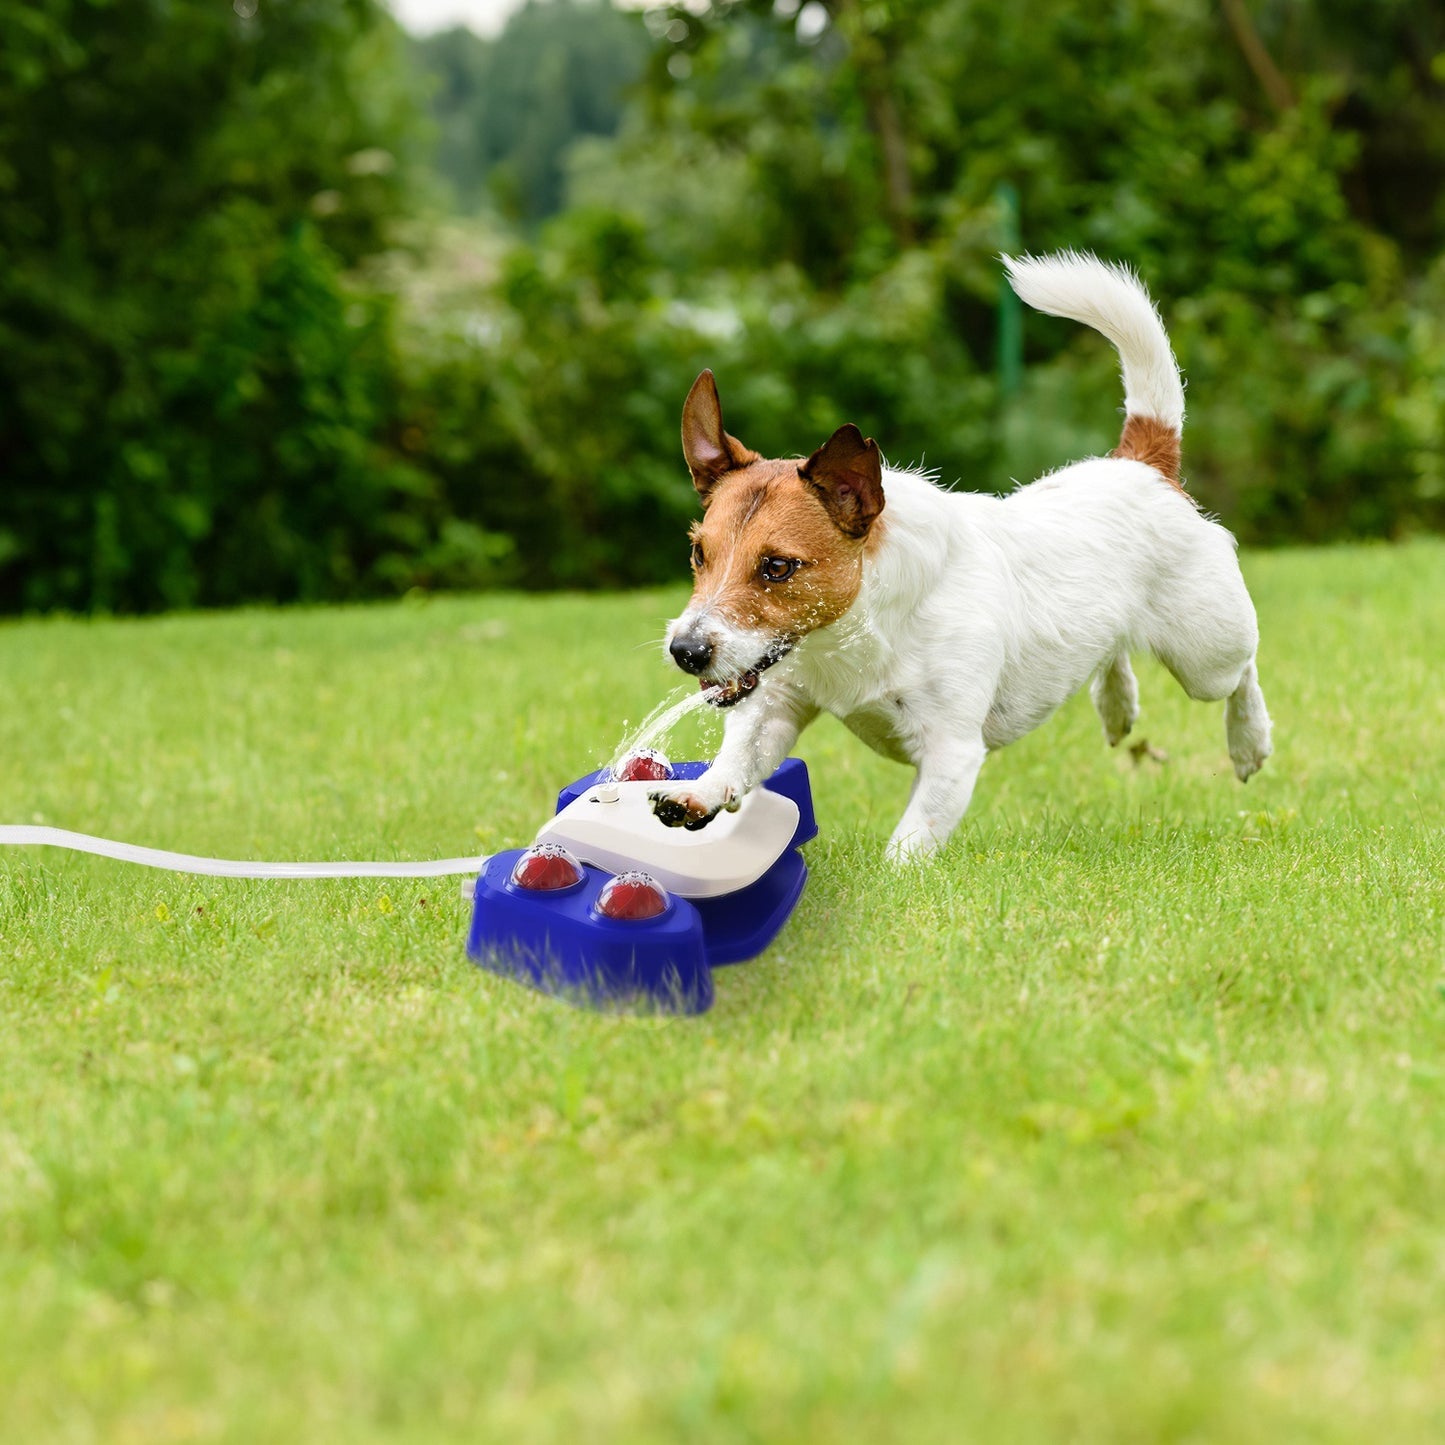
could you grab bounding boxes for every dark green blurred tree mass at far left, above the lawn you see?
[0,0,456,610]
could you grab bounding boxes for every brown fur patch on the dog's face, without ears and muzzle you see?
[692,461,867,639]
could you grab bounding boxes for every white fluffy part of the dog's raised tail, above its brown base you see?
[1001,251,1183,436]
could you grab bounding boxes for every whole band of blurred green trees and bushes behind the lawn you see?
[0,0,1445,610]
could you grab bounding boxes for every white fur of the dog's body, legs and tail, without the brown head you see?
[661,253,1270,861]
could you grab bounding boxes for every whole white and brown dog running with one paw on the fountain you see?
[650,251,1272,863]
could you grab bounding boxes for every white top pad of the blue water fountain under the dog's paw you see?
[536,782,798,899]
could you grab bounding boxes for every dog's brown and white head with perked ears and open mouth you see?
[668,371,883,707]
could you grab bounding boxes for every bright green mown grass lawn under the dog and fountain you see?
[0,542,1445,1445]
